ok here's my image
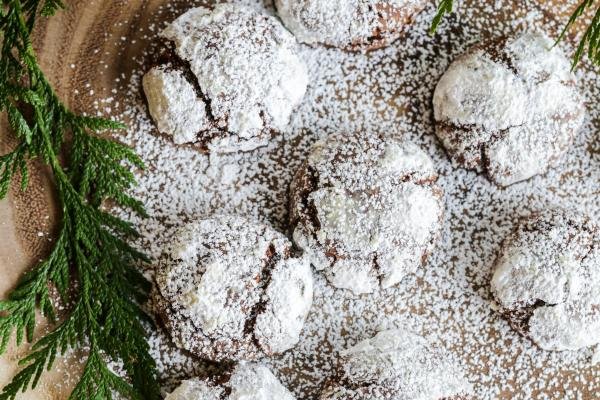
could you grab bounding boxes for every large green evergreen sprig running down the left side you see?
[0,0,160,400]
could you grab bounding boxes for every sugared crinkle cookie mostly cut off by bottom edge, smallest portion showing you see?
[165,362,295,400]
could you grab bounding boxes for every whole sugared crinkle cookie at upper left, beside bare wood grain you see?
[143,4,308,153]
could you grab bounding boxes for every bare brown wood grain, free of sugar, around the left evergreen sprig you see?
[0,0,596,399]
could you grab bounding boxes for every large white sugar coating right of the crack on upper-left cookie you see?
[145,4,308,152]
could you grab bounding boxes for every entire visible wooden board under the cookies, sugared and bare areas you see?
[0,0,600,399]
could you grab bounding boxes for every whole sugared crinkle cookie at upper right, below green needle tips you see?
[433,32,585,187]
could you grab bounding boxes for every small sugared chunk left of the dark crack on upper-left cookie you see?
[143,66,210,144]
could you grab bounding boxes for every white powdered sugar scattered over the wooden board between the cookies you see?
[95,0,600,400]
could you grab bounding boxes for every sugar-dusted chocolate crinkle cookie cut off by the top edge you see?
[275,0,427,51]
